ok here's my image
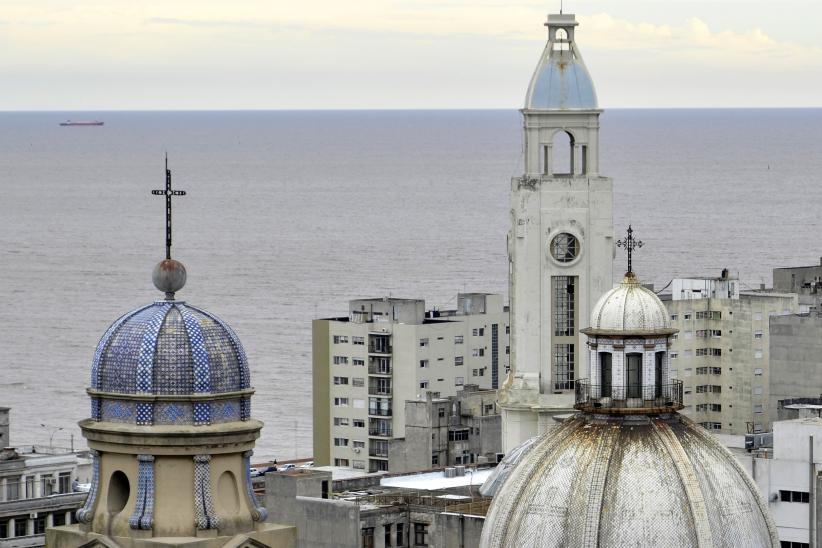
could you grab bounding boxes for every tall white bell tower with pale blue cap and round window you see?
[499,14,614,452]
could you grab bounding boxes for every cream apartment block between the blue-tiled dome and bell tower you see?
[312,293,509,471]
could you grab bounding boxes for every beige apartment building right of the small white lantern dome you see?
[661,270,799,435]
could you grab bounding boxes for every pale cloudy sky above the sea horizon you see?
[0,0,822,111]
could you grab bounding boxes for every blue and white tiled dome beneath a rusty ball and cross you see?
[89,301,251,425]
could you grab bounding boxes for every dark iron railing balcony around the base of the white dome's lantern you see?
[574,379,683,414]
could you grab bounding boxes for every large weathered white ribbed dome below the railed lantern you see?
[480,413,779,548]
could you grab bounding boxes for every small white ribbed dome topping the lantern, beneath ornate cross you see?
[583,273,676,335]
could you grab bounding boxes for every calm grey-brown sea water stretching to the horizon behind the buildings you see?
[0,110,822,458]
